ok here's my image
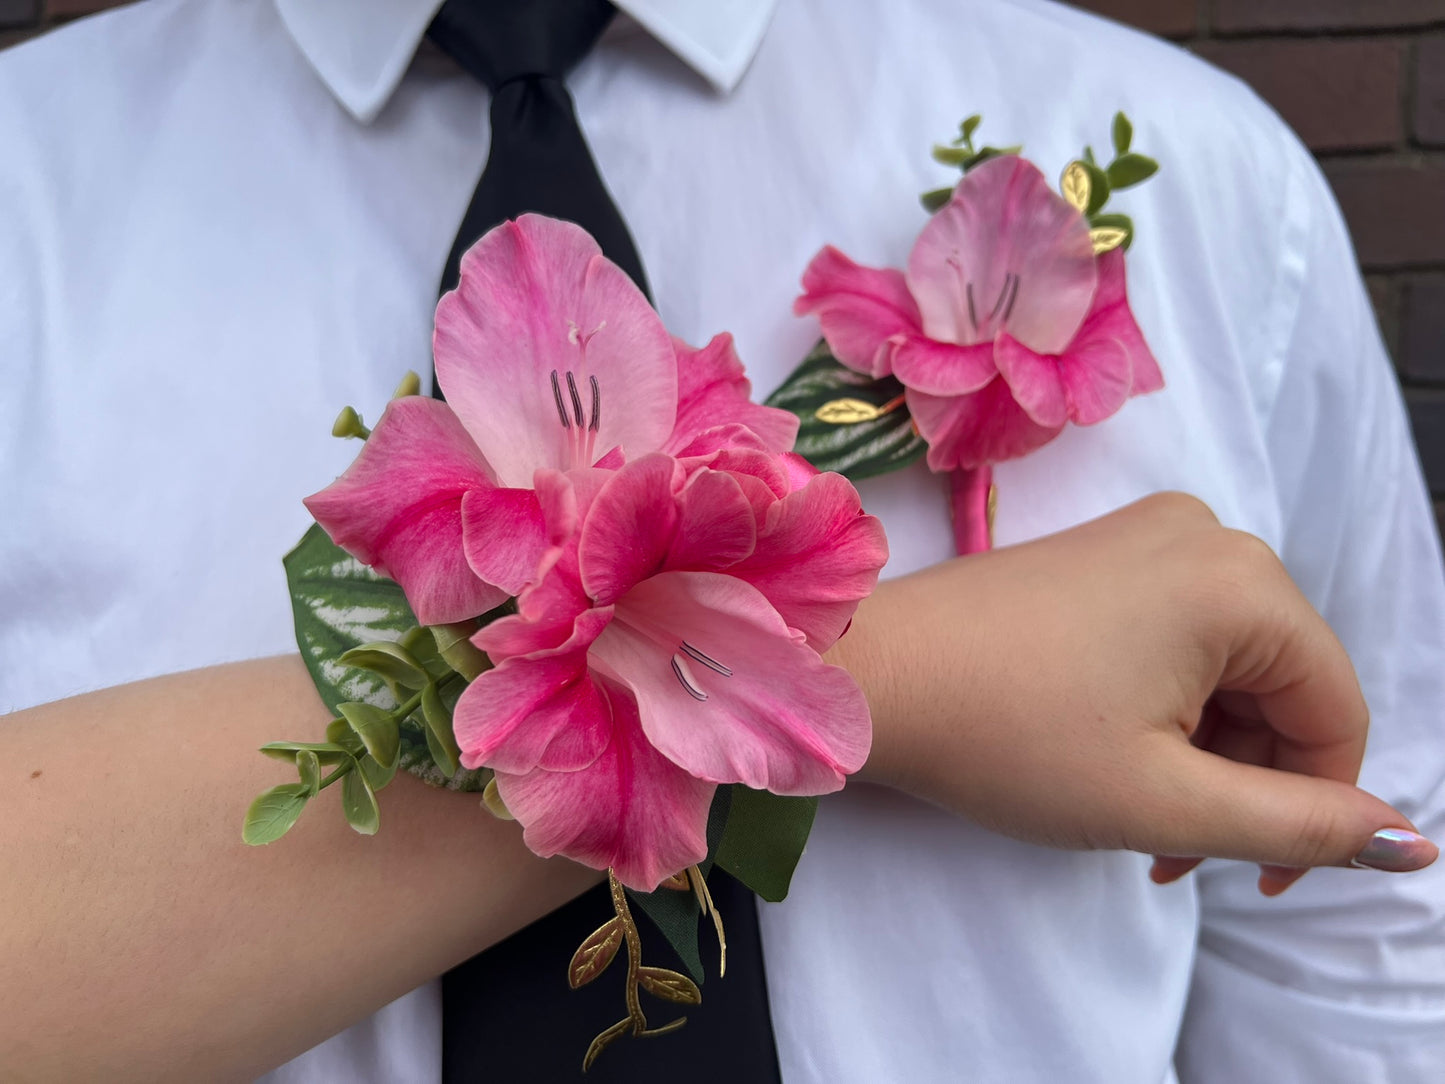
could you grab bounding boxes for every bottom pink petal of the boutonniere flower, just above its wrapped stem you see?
[907,376,1064,473]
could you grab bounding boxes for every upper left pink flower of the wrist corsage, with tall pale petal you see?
[306,214,798,624]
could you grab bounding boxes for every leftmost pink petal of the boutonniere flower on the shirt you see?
[793,244,920,376]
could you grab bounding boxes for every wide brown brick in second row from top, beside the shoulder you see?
[1195,39,1405,150]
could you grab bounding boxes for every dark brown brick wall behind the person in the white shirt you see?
[0,0,1445,543]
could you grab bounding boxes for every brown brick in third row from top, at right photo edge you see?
[1325,159,1445,269]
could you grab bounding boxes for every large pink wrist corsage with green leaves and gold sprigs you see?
[243,215,887,1068]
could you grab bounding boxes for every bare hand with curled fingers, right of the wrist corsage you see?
[829,494,1438,895]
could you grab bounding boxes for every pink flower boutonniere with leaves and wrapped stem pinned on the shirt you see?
[767,113,1163,554]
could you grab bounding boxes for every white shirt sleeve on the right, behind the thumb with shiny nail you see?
[1176,147,1445,1084]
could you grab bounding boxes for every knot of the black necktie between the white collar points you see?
[426,0,617,94]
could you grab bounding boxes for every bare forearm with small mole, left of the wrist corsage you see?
[0,656,598,1081]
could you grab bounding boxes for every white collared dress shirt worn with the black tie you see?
[0,0,1445,1084]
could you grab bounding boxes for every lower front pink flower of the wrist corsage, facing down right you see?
[455,453,887,892]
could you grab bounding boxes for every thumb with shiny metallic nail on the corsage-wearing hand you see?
[1146,746,1439,873]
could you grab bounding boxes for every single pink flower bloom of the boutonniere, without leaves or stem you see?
[793,156,1163,471]
